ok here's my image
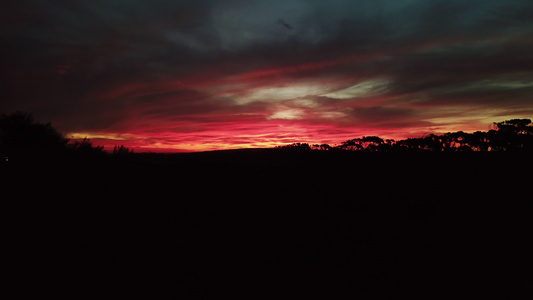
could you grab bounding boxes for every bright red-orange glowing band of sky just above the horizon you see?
[67,120,485,152]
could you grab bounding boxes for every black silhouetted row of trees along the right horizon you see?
[279,119,533,152]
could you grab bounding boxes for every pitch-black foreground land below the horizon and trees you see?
[0,150,533,299]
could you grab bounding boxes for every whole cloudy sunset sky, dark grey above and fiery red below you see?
[0,0,533,152]
